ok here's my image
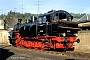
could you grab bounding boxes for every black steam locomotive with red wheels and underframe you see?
[9,10,80,51]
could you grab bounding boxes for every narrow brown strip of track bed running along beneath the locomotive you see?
[8,46,90,59]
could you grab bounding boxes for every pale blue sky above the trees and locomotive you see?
[0,0,90,14]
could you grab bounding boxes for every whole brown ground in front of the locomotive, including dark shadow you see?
[0,45,90,60]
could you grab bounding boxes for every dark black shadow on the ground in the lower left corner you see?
[0,48,14,60]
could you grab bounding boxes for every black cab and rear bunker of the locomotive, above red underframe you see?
[38,10,78,35]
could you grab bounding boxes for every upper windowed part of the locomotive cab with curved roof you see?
[39,10,73,23]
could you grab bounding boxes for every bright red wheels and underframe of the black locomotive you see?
[9,31,76,50]
